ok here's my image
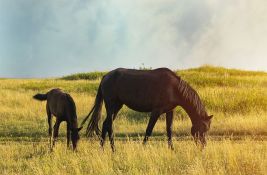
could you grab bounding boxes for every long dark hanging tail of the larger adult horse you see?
[81,83,103,137]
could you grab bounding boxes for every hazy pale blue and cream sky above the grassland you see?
[0,0,267,78]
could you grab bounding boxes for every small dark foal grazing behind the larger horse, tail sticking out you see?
[33,89,81,150]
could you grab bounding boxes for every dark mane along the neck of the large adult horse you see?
[177,76,207,117]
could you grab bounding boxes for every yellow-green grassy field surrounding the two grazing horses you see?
[0,66,267,174]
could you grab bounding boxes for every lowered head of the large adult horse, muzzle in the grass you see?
[191,115,213,146]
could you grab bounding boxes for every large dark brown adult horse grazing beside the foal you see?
[82,68,212,151]
